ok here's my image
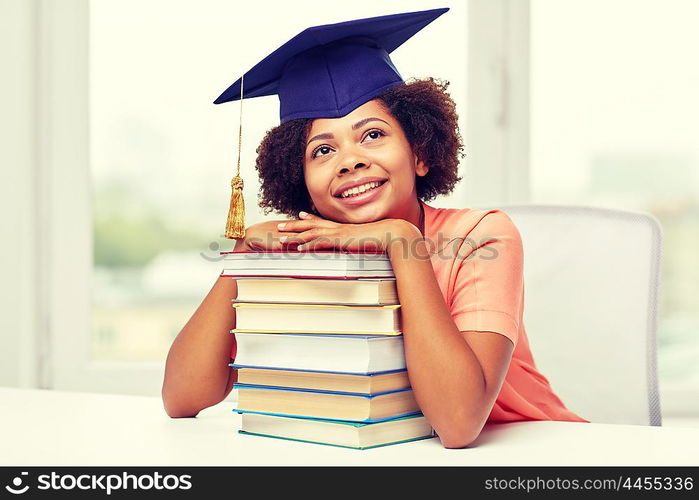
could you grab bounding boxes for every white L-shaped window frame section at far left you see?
[36,0,164,395]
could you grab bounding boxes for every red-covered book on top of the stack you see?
[221,250,394,278]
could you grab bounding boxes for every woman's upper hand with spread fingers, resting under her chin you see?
[277,212,420,252]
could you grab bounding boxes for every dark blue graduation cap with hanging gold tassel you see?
[214,8,449,238]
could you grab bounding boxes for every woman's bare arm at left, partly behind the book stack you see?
[162,220,292,417]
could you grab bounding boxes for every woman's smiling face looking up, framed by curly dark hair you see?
[304,100,428,223]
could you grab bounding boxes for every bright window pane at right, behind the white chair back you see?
[531,0,699,402]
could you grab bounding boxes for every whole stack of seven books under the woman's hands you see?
[221,251,433,449]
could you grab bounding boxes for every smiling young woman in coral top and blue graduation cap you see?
[163,9,586,448]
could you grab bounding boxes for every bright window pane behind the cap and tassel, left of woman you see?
[90,0,467,361]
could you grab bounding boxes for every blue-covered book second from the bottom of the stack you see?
[233,383,420,422]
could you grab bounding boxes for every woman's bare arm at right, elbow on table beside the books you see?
[387,221,514,448]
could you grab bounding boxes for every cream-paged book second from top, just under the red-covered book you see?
[236,276,399,305]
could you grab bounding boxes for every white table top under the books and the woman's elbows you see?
[0,388,699,466]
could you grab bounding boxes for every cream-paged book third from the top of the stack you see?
[233,300,401,335]
